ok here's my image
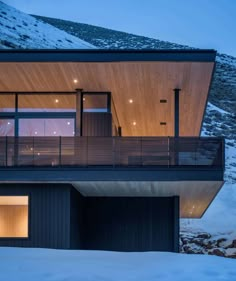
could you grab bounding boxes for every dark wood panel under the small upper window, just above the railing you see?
[82,112,112,137]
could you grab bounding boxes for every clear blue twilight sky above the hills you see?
[3,0,236,57]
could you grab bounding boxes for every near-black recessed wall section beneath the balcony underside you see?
[83,197,179,251]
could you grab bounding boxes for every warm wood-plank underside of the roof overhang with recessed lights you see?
[0,62,214,136]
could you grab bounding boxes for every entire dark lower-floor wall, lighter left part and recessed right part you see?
[0,184,179,252]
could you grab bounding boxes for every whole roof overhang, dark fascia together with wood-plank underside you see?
[0,50,216,136]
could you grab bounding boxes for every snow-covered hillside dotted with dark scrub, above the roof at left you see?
[0,1,95,49]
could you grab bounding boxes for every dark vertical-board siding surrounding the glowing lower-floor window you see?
[0,184,71,249]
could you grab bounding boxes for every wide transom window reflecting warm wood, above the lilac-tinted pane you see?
[18,94,76,112]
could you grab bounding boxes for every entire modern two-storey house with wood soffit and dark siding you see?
[0,50,224,252]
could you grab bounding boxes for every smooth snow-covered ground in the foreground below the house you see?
[0,248,236,281]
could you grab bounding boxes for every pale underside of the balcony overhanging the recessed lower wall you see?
[72,181,223,218]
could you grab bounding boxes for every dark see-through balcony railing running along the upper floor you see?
[0,137,224,169]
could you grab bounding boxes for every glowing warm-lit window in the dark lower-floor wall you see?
[0,196,29,238]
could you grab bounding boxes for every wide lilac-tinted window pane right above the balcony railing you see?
[19,118,75,137]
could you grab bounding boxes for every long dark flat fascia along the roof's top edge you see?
[0,49,216,63]
